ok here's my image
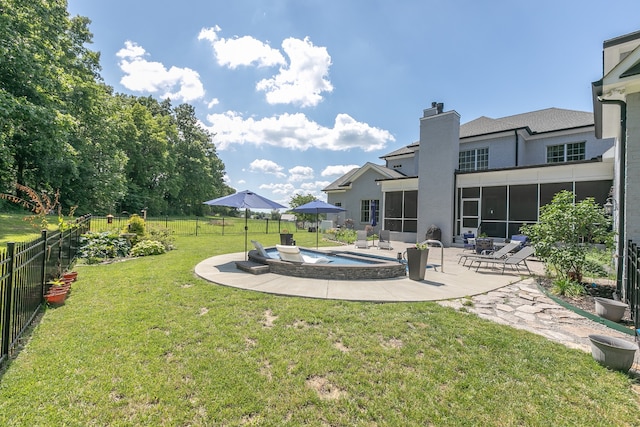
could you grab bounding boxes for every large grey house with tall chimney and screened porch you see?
[323,102,615,246]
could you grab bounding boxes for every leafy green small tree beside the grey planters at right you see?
[520,190,613,282]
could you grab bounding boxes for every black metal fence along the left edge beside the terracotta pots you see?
[0,216,91,365]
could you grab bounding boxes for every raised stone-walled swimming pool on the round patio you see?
[249,247,406,280]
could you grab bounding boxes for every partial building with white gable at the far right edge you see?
[592,27,640,294]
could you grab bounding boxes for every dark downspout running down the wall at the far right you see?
[598,97,627,298]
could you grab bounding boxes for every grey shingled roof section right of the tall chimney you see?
[460,108,594,138]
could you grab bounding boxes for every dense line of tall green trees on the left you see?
[0,0,234,215]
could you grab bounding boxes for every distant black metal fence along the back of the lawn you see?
[91,216,296,236]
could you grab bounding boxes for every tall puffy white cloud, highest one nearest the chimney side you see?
[256,37,333,107]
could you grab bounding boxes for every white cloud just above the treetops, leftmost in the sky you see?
[116,40,204,102]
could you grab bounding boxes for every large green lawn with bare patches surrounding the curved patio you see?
[0,227,640,426]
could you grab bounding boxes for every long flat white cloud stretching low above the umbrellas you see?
[207,111,395,152]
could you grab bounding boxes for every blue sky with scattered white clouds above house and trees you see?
[68,0,640,205]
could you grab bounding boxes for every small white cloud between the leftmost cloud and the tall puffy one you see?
[198,25,285,69]
